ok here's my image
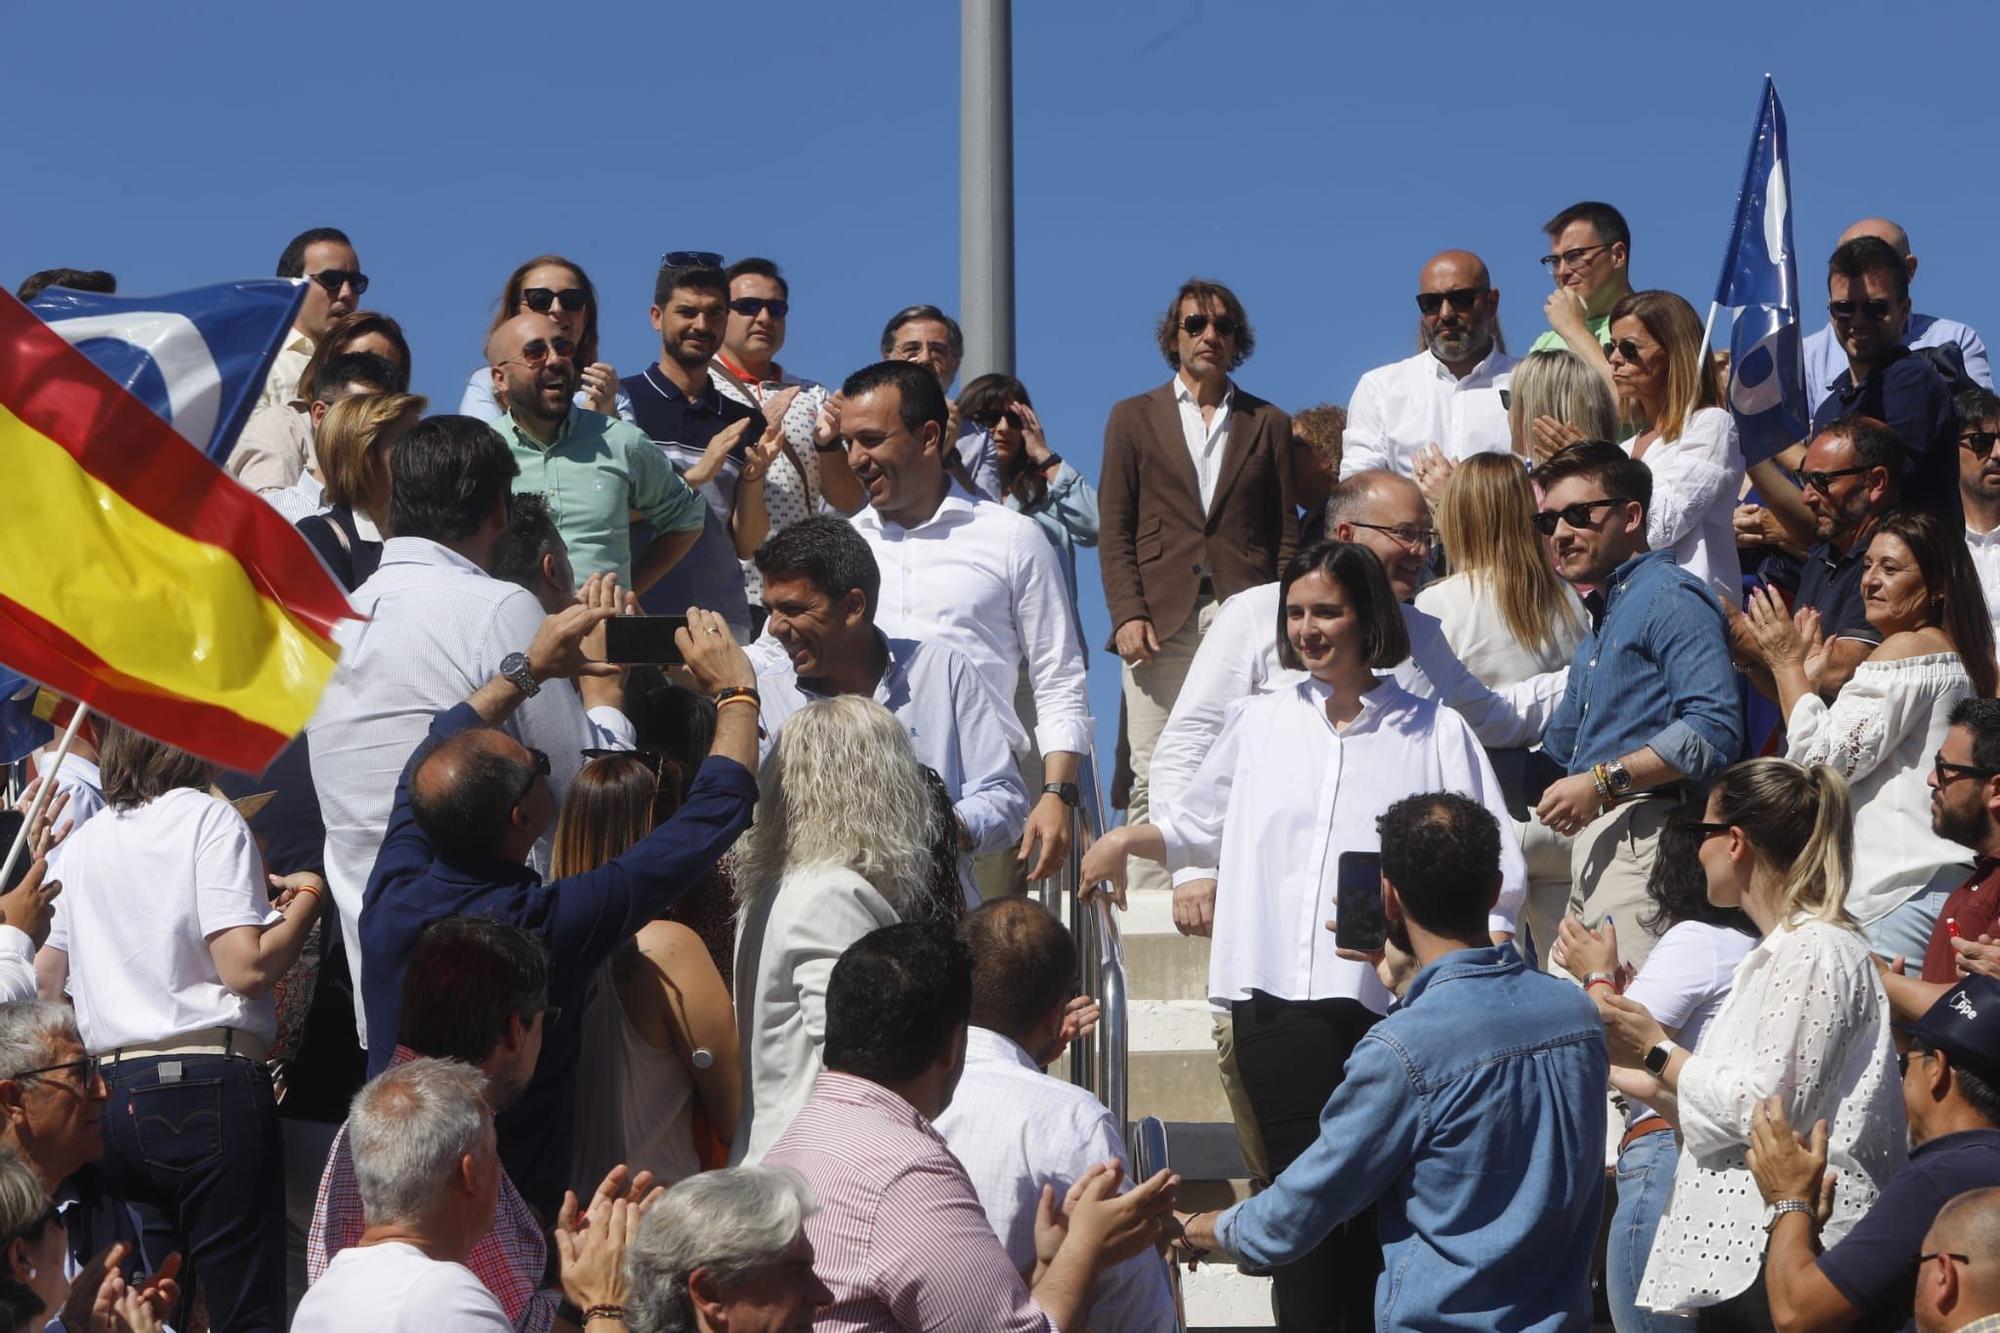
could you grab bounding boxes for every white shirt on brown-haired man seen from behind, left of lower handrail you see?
[932,1027,1174,1333]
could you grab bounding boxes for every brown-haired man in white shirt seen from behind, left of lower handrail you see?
[934,899,1174,1333]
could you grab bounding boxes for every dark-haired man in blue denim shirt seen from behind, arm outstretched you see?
[1182,793,1610,1333]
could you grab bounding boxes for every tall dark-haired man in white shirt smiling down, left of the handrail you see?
[840,360,1090,879]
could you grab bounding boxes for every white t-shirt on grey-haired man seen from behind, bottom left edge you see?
[292,1241,514,1333]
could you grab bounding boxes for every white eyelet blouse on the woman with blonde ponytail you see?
[1638,917,1908,1311]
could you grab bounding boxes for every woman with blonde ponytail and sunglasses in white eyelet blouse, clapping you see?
[1598,759,1908,1327]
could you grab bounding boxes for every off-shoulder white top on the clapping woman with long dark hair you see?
[1786,652,1972,925]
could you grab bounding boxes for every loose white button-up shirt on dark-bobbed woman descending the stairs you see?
[1152,677,1528,1013]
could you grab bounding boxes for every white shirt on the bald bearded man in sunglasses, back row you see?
[1340,348,1514,480]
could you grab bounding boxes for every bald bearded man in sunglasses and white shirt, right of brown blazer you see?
[1340,250,1514,480]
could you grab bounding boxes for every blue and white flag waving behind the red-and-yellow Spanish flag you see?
[28,278,306,462]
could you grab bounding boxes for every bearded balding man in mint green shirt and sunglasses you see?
[486,314,708,592]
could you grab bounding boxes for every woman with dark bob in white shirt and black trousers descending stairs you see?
[1084,542,1524,1327]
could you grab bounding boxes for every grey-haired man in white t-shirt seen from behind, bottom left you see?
[292,1059,514,1333]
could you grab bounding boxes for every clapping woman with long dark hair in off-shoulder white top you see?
[1744,512,1996,959]
